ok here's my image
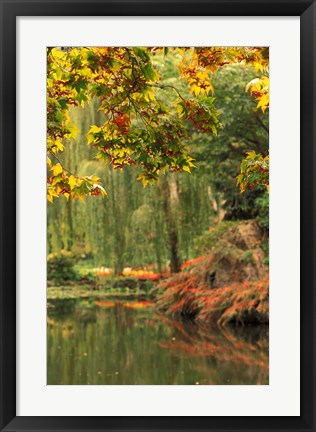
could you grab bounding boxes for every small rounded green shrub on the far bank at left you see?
[47,250,79,285]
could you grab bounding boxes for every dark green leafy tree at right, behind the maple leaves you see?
[190,65,269,220]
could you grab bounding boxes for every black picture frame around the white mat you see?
[0,0,316,432]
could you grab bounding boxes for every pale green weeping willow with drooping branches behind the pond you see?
[48,100,214,274]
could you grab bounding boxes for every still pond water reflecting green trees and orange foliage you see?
[47,300,269,385]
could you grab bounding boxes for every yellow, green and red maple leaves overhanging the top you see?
[47,47,269,202]
